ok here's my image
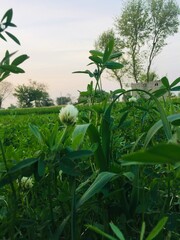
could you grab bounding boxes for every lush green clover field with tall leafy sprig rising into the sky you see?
[0,6,180,240]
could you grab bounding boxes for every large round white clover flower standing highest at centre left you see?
[59,104,78,125]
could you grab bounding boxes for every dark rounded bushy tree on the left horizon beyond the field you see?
[13,81,53,107]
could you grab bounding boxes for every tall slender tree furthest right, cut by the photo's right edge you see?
[147,0,180,81]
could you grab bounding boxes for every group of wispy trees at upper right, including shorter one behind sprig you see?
[95,0,180,84]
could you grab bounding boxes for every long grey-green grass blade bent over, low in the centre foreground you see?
[76,172,117,209]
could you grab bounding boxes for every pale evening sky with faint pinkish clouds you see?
[0,0,180,107]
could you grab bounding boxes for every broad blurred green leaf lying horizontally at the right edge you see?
[122,144,180,165]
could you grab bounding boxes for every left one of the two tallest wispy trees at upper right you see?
[115,0,150,82]
